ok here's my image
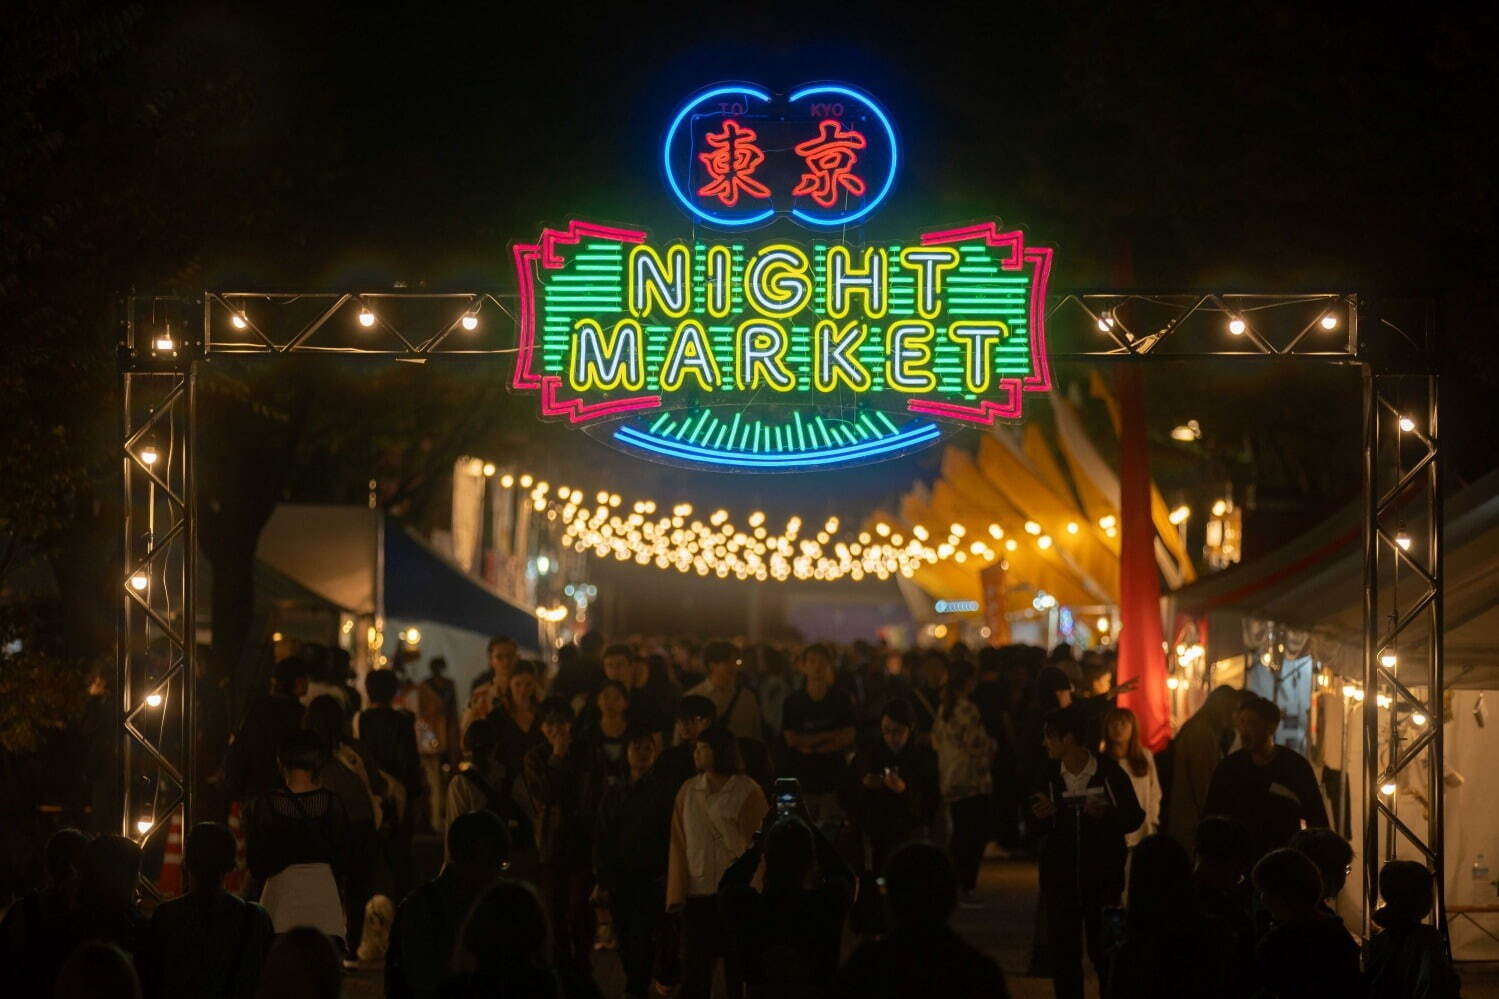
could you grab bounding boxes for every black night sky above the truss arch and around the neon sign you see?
[6,2,1499,633]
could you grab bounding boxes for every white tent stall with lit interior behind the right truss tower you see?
[1168,473,1499,960]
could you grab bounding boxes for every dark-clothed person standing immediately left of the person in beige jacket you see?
[594,726,679,996]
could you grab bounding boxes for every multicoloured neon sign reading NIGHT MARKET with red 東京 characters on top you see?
[513,84,1051,471]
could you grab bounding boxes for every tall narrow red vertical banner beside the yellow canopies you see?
[1117,365,1171,752]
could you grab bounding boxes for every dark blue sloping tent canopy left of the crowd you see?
[385,521,540,650]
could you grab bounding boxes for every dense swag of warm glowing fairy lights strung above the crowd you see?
[486,465,1117,582]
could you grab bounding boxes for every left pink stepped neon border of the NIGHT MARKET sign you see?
[510,219,661,423]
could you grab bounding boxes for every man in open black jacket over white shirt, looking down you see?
[1031,708,1145,999]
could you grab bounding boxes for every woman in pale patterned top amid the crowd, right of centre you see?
[932,659,997,905]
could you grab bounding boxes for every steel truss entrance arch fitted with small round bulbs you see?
[115,290,1447,933]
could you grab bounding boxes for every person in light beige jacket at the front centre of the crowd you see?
[666,726,770,999]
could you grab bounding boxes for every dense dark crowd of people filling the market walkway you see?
[0,635,1457,999]
